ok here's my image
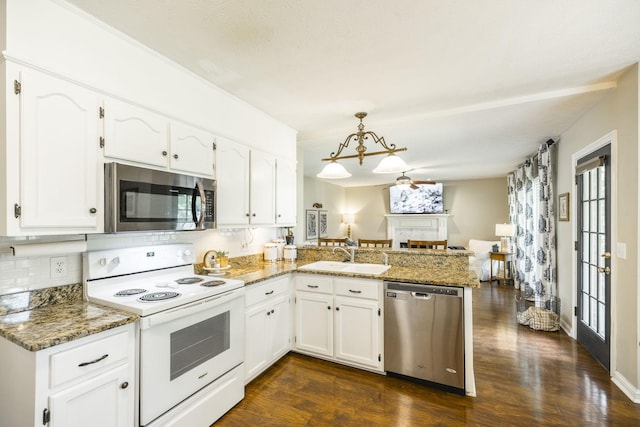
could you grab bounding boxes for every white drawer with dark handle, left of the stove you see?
[50,330,130,388]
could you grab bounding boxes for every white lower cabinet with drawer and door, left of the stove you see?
[0,324,136,427]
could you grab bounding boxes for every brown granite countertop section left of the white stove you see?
[0,285,138,351]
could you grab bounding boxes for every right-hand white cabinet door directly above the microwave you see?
[169,122,214,178]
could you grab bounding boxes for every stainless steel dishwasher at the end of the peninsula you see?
[384,282,465,394]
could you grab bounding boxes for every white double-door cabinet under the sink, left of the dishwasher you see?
[295,274,384,372]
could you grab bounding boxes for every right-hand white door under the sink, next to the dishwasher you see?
[335,297,381,368]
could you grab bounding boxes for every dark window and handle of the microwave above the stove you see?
[120,181,201,223]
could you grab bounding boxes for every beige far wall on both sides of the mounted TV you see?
[304,177,509,246]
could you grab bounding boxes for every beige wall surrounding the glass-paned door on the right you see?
[556,65,639,388]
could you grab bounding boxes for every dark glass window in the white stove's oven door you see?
[170,311,231,381]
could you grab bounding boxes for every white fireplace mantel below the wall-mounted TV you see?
[385,214,451,249]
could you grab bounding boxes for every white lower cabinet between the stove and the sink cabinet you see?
[244,275,291,383]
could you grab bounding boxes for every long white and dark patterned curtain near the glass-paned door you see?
[507,143,556,299]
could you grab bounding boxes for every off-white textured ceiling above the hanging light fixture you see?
[68,0,640,186]
